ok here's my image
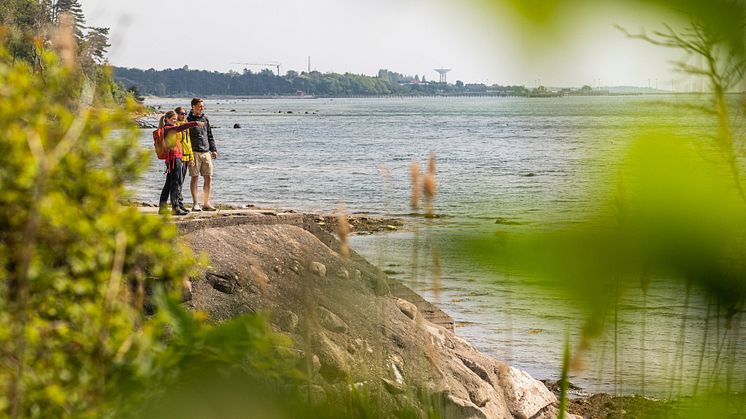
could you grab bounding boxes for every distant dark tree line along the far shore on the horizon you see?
[114,66,531,97]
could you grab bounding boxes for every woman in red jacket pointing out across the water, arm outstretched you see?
[158,111,205,215]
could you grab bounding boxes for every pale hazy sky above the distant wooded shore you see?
[81,0,686,89]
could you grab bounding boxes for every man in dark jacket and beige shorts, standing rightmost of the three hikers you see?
[187,97,218,211]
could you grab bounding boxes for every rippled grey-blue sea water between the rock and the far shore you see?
[133,96,746,396]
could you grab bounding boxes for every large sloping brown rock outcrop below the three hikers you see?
[179,214,568,418]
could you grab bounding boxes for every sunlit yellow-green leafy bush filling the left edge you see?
[0,31,182,417]
